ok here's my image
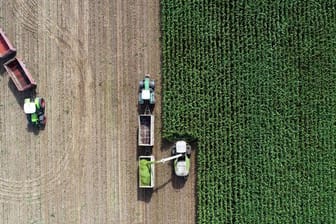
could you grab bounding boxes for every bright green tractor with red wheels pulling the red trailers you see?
[23,97,47,128]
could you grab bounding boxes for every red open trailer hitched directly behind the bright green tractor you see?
[4,58,36,91]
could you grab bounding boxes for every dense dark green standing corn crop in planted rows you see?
[161,0,336,224]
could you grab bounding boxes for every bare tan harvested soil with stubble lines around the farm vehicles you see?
[0,0,195,224]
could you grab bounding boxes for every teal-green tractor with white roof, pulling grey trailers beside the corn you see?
[139,74,155,105]
